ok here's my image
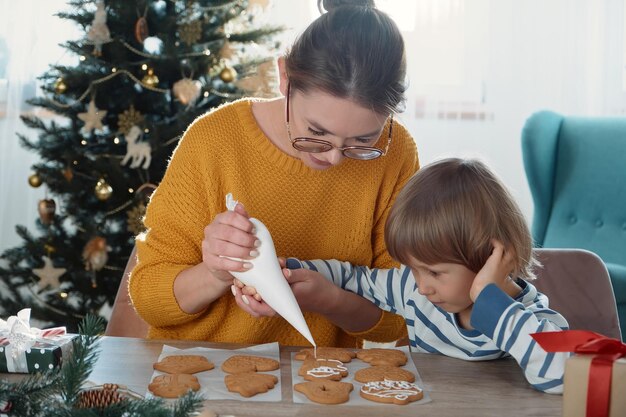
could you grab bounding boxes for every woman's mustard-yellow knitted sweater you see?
[129,99,418,347]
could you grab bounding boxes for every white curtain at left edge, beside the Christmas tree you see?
[0,0,78,251]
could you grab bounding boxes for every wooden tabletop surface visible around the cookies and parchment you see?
[0,337,562,417]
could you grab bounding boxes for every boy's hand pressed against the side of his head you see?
[470,239,521,302]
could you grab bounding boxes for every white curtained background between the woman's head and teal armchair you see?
[387,0,626,220]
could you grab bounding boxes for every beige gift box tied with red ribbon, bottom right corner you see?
[532,330,626,417]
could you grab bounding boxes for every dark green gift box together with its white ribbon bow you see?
[0,308,76,373]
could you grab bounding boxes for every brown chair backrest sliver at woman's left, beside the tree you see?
[104,247,149,338]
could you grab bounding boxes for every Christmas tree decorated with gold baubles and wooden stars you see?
[0,0,281,330]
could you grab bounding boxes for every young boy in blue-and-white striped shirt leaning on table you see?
[233,159,569,393]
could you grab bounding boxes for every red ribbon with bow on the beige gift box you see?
[531,330,626,417]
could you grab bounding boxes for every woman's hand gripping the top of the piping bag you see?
[202,204,259,282]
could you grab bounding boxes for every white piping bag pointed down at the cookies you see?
[226,193,316,346]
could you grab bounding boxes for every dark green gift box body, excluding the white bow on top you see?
[0,333,77,373]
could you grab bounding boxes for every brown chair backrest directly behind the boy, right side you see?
[533,249,621,340]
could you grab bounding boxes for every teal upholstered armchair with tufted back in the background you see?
[522,111,626,340]
